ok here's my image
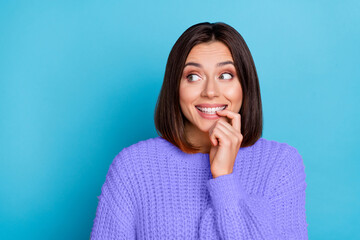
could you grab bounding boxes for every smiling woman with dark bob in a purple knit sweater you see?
[91,23,308,240]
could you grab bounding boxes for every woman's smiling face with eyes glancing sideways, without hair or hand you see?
[179,41,243,135]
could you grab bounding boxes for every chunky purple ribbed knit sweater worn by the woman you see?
[91,137,308,240]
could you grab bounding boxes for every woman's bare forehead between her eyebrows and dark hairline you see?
[186,41,233,62]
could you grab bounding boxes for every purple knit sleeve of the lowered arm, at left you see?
[91,150,135,240]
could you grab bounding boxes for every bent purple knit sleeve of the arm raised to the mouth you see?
[199,147,308,240]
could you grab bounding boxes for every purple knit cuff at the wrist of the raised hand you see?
[207,173,247,211]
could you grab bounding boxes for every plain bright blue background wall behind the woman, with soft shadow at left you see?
[0,0,360,239]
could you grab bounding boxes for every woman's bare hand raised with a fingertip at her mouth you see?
[209,110,243,178]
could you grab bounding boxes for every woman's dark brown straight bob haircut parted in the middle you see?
[154,22,263,153]
